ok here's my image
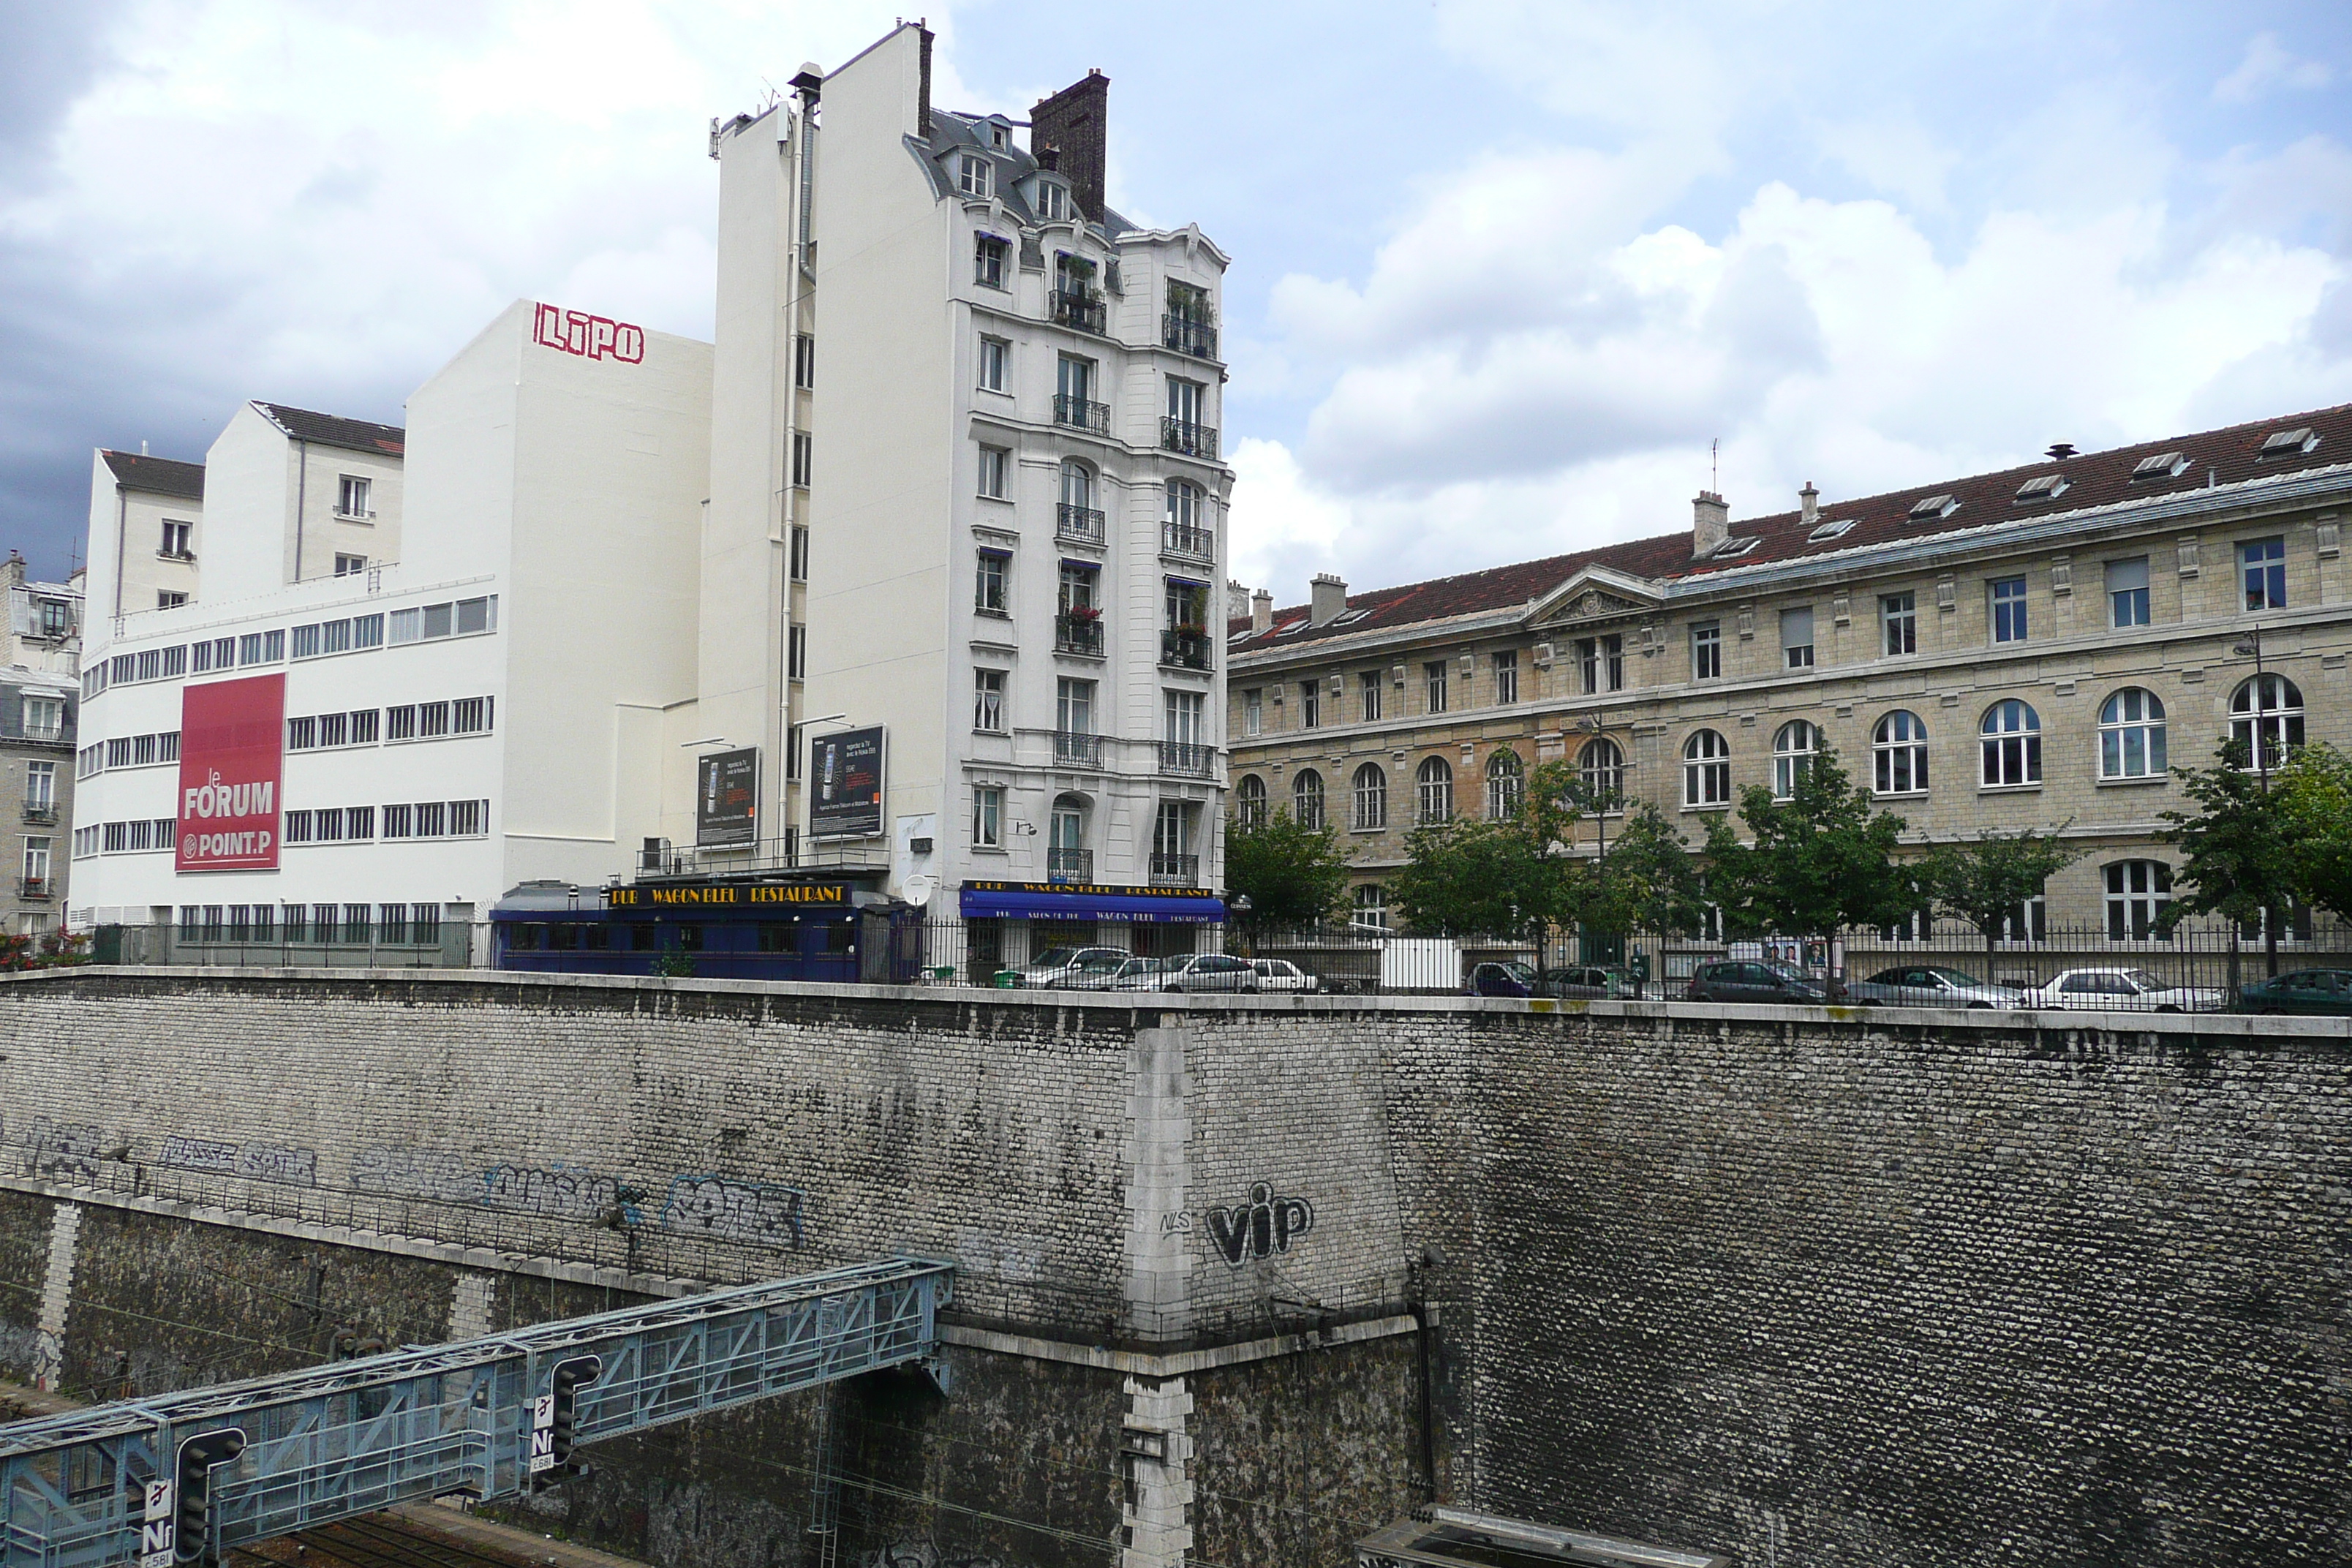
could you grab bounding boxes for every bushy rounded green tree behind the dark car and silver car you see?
[1705,753,1919,935]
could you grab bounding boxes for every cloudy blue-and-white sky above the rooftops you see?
[0,0,2352,604]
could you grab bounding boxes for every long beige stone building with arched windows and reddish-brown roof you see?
[1228,407,2352,945]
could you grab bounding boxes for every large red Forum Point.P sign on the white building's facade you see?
[176,675,287,872]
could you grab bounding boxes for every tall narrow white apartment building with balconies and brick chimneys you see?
[701,23,1230,962]
